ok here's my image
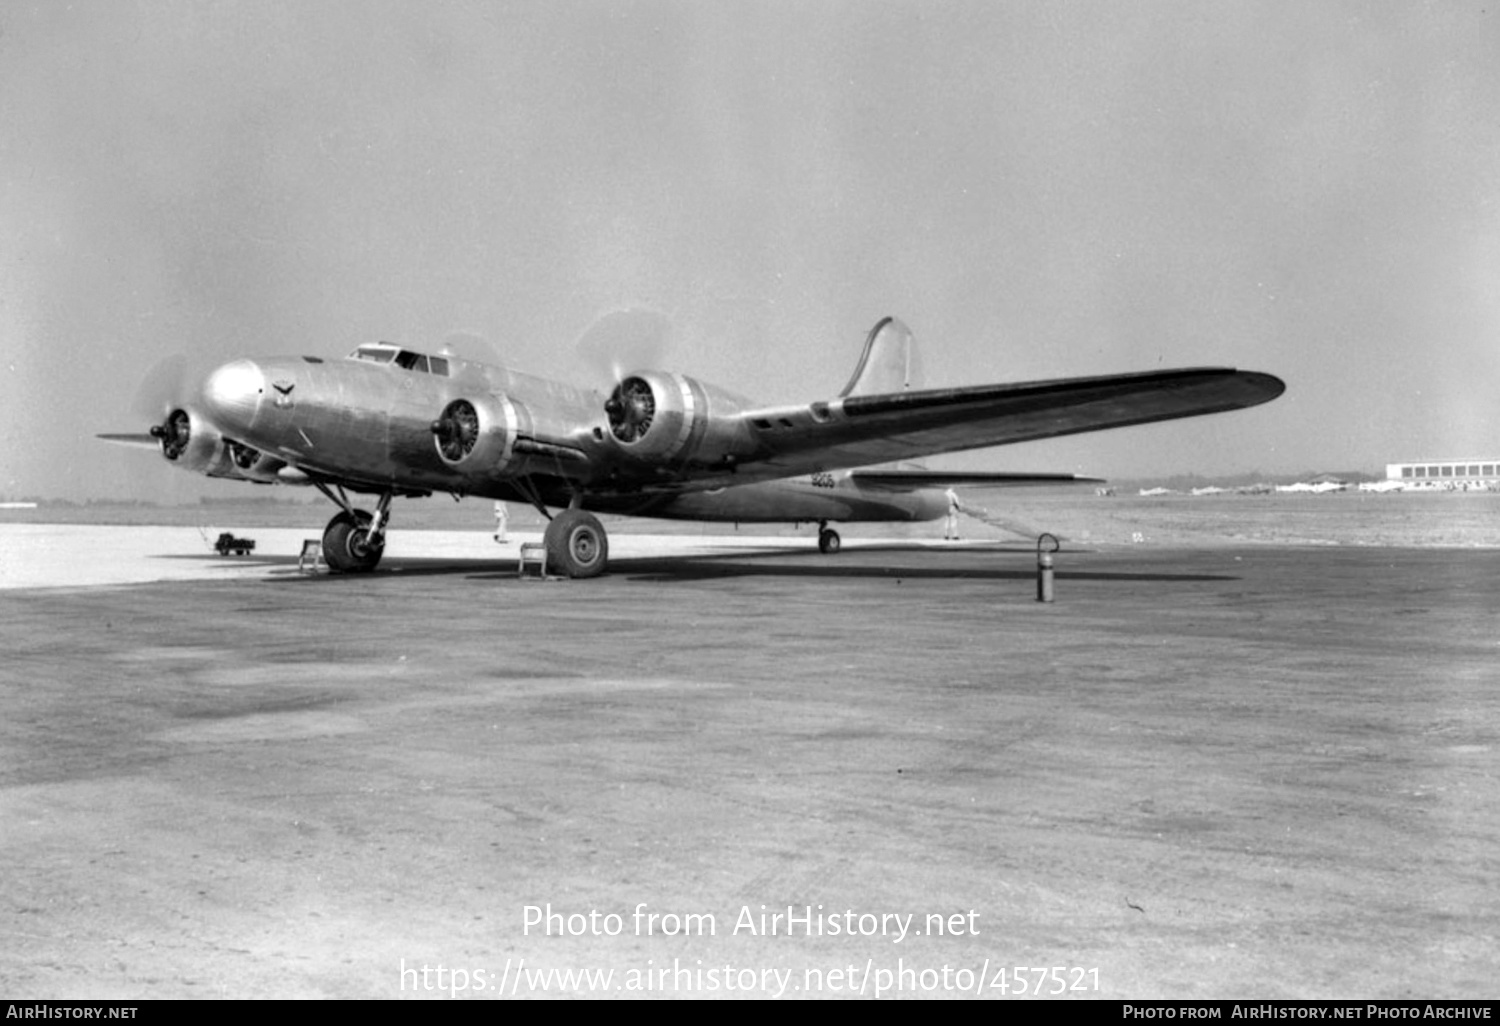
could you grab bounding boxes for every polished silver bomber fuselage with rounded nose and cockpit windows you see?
[203,348,947,524]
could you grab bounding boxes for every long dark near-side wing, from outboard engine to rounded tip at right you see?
[740,368,1286,482]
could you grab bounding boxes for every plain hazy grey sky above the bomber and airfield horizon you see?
[0,0,1500,498]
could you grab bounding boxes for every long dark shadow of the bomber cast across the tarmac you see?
[164,543,1239,587]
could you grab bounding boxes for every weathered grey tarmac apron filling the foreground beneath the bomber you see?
[0,531,1500,999]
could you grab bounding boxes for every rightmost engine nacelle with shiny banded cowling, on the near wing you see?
[605,371,753,464]
